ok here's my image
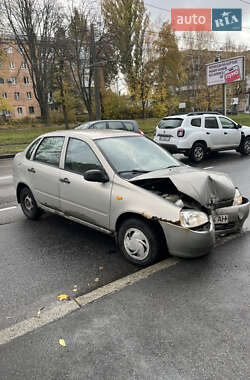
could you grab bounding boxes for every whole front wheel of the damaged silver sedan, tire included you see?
[118,218,162,266]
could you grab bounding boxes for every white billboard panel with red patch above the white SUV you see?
[206,57,245,86]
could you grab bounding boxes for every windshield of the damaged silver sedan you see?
[96,136,181,178]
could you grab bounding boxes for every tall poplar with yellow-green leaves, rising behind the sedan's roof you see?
[102,0,152,117]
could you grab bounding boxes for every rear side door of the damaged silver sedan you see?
[27,136,65,210]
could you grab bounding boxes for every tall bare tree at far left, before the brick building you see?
[3,0,62,124]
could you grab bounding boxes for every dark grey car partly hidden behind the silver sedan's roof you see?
[74,120,144,135]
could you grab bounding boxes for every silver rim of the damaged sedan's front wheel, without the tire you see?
[124,228,149,261]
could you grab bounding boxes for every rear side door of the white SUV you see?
[204,116,225,149]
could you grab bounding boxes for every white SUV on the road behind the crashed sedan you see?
[154,112,250,162]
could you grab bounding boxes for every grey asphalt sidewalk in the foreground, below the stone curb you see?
[0,234,250,380]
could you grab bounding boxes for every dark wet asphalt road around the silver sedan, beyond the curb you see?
[0,152,250,329]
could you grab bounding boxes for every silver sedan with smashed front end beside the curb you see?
[13,130,249,266]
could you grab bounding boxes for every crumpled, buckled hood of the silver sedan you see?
[129,166,235,207]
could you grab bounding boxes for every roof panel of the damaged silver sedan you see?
[38,129,141,140]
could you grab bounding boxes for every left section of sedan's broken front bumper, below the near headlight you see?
[160,218,215,258]
